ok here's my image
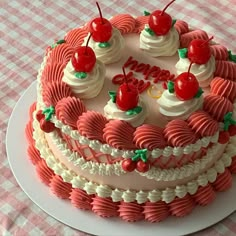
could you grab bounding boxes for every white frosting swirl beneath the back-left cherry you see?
[83,28,124,64]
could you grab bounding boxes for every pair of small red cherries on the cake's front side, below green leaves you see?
[122,158,150,173]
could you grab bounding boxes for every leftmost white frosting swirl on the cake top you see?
[62,59,106,99]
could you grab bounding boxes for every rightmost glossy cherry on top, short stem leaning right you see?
[188,36,213,65]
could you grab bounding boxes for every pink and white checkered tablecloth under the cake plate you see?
[0,0,236,236]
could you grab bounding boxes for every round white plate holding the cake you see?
[6,82,236,236]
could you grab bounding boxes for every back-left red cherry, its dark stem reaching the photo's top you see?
[89,2,112,43]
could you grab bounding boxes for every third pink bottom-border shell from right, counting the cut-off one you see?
[193,184,216,206]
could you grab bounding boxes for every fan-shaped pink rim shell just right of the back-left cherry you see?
[110,14,135,34]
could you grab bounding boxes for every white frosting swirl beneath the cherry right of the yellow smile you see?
[157,90,203,120]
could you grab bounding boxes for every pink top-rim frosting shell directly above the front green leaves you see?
[134,124,166,150]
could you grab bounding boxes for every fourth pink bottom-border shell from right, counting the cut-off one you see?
[169,194,195,217]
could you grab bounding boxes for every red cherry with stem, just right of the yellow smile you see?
[174,62,199,100]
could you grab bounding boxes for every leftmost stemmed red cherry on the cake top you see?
[71,34,96,72]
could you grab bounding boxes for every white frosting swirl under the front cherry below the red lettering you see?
[104,99,148,127]
